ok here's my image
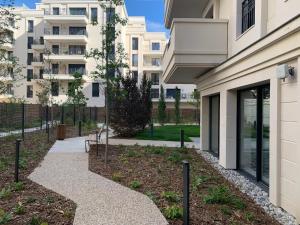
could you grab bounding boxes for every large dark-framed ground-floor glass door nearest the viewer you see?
[237,85,270,185]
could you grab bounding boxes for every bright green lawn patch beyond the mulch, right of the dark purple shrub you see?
[135,125,200,141]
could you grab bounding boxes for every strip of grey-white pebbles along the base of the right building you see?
[197,151,297,225]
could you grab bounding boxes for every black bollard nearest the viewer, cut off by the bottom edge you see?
[182,160,190,225]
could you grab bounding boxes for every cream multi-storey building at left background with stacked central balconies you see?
[7,0,127,107]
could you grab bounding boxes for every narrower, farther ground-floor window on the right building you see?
[209,95,220,156]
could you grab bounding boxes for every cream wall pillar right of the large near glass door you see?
[269,76,281,206]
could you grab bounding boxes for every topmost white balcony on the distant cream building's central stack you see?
[44,11,89,25]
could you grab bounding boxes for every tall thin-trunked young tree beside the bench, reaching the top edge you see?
[86,0,128,164]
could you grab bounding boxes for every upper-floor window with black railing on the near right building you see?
[242,0,255,33]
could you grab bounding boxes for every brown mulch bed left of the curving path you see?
[0,131,76,225]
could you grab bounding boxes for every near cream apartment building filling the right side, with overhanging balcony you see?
[163,0,300,223]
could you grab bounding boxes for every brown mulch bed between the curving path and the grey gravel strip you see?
[89,145,279,225]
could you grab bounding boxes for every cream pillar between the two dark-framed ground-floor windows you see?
[219,90,237,169]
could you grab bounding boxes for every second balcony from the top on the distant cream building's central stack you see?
[44,29,88,44]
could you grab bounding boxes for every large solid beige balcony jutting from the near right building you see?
[163,19,228,84]
